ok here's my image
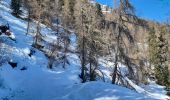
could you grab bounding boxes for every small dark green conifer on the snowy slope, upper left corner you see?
[11,0,21,17]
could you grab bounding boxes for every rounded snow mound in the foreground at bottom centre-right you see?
[60,82,152,100]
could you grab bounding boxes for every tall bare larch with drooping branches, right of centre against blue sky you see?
[112,0,134,84]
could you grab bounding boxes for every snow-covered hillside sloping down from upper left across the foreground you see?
[0,0,168,100]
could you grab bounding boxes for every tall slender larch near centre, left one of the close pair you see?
[75,0,88,83]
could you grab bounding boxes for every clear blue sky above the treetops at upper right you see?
[96,0,170,21]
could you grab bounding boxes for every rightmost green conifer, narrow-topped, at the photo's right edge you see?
[155,28,170,87]
